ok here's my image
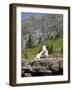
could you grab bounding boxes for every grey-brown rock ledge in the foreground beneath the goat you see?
[21,58,63,77]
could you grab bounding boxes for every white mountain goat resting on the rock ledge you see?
[35,46,48,60]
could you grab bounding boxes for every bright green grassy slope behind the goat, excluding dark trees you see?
[21,38,63,60]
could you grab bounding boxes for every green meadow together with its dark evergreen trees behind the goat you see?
[22,36,63,60]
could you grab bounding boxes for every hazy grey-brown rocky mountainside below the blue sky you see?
[21,14,63,48]
